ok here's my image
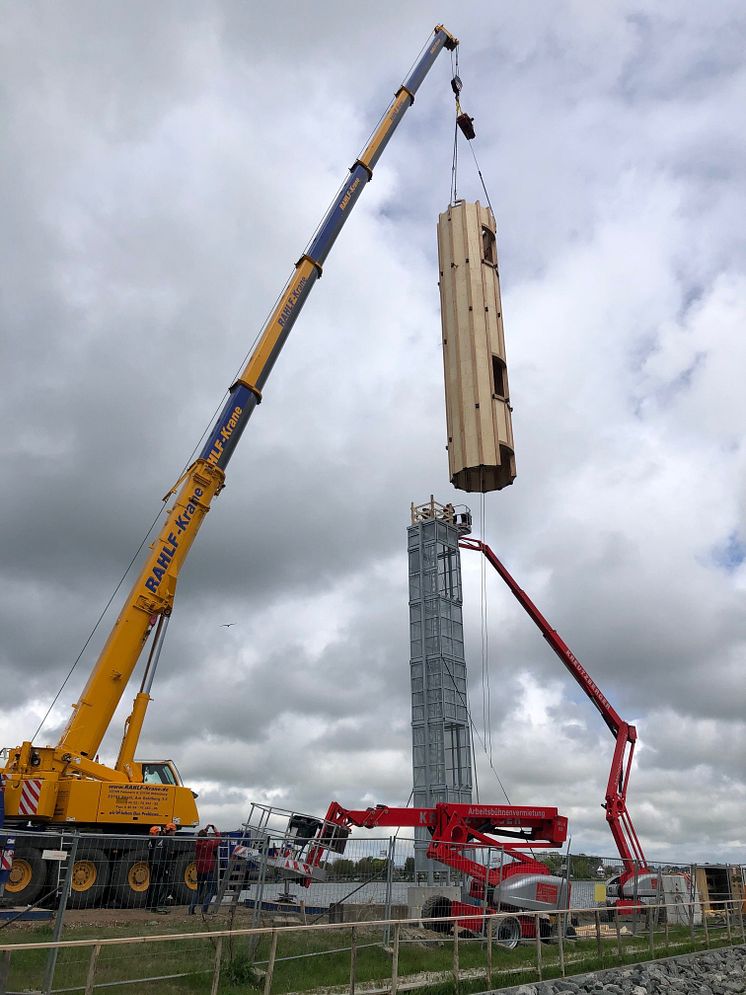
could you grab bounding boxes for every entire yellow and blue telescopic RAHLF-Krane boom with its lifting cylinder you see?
[2,25,458,792]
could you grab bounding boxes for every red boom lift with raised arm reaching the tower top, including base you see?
[459,538,659,909]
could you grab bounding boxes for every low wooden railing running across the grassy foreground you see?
[0,901,746,995]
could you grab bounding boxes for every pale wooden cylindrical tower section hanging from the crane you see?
[438,200,516,493]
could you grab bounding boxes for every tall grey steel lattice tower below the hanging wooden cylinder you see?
[407,496,472,880]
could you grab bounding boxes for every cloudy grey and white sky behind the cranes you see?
[0,0,746,860]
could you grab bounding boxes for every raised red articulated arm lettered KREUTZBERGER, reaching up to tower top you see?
[459,537,647,872]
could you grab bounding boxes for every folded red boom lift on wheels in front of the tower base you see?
[307,802,570,947]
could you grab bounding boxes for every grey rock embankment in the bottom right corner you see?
[492,946,746,995]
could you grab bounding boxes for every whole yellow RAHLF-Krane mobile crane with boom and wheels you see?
[0,25,458,905]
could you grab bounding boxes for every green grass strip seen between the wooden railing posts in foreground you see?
[0,915,736,995]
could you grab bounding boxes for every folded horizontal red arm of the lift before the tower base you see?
[308,802,567,884]
